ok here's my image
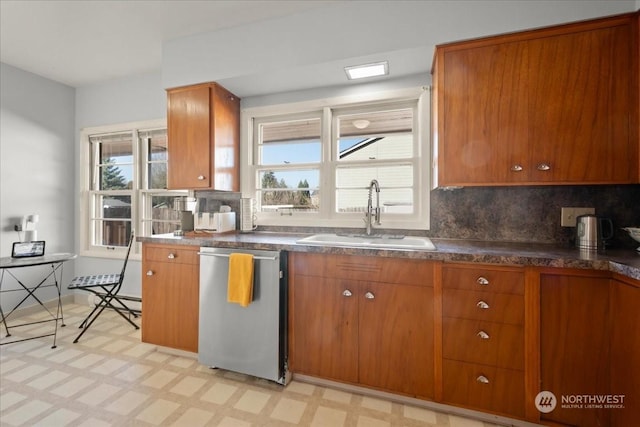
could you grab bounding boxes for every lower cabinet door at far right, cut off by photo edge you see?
[611,280,640,427]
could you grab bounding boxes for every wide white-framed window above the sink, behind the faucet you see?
[242,90,429,229]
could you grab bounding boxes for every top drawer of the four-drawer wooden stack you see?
[442,265,524,295]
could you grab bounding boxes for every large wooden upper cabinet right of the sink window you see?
[433,13,639,186]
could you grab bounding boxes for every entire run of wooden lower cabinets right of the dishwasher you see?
[292,253,640,427]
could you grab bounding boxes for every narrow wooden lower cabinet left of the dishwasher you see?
[142,243,200,352]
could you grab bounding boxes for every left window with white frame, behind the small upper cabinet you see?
[81,122,187,256]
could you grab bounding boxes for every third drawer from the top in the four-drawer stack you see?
[442,317,524,369]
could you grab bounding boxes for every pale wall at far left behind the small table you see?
[0,63,77,310]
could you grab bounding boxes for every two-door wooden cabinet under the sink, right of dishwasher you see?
[289,253,434,398]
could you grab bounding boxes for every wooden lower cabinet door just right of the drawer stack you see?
[540,274,609,427]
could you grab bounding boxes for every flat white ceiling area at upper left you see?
[0,0,344,87]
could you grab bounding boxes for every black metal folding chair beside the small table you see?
[67,231,140,343]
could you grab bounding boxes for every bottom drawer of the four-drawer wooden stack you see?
[442,359,524,417]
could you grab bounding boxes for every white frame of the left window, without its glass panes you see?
[79,119,188,259]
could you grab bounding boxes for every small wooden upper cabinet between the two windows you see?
[167,83,240,191]
